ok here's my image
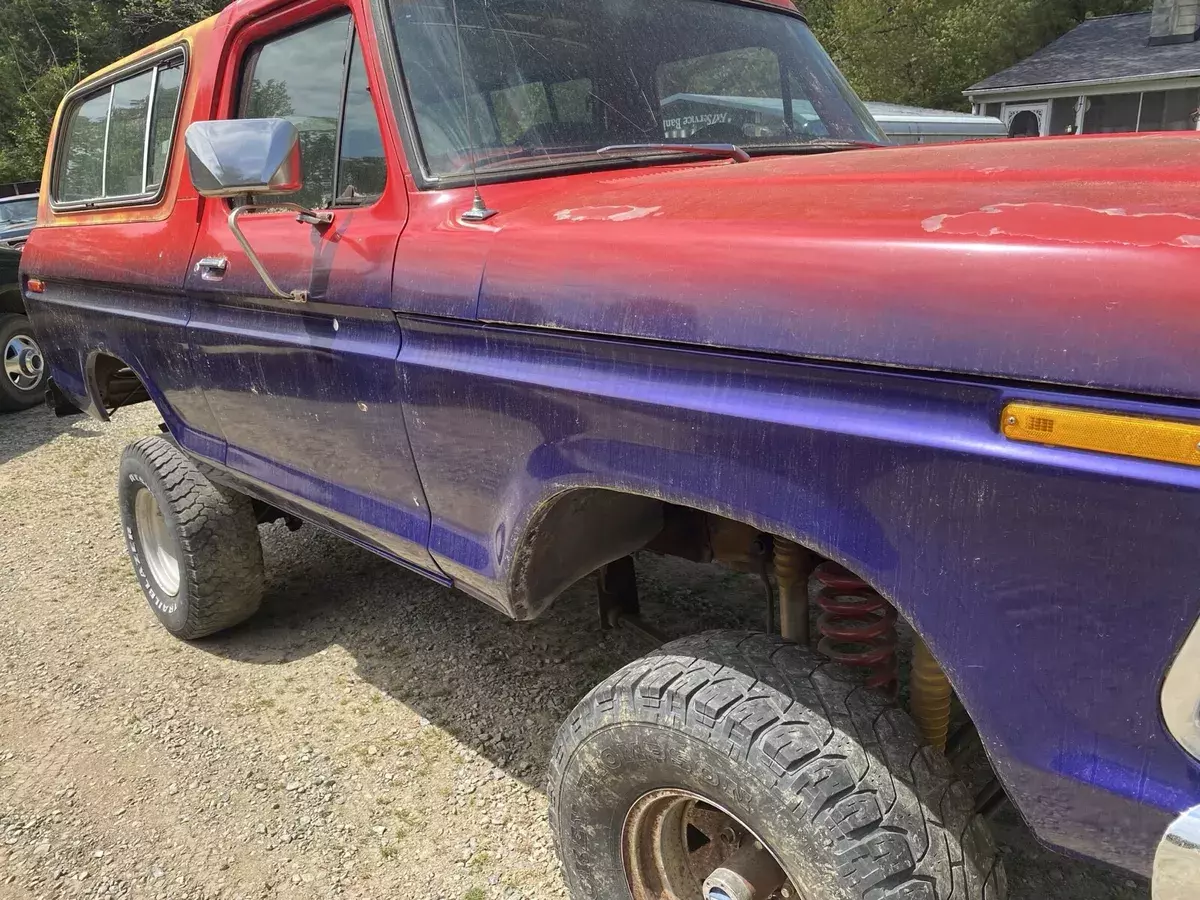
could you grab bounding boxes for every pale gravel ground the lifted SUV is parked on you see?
[0,406,1148,900]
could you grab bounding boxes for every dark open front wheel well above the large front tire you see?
[510,487,984,777]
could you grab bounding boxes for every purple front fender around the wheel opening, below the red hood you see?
[400,318,1200,872]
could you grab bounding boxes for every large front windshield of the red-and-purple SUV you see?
[390,0,886,176]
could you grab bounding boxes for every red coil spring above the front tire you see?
[812,563,900,696]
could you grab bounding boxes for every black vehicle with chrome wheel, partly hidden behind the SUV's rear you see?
[0,182,46,412]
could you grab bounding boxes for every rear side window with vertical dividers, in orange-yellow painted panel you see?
[52,55,184,205]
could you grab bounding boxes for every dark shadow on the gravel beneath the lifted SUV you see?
[198,526,1148,900]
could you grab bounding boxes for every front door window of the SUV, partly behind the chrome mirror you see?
[239,13,386,209]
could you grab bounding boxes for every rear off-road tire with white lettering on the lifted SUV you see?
[118,438,264,641]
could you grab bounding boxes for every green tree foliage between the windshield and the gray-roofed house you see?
[800,0,1151,108]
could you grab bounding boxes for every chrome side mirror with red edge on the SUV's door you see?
[184,119,304,197]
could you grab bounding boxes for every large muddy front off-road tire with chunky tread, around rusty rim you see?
[548,631,1007,900]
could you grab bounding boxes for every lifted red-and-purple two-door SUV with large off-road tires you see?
[22,0,1200,900]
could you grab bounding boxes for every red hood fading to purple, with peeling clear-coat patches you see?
[480,133,1200,397]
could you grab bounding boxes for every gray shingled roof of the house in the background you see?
[965,12,1200,94]
